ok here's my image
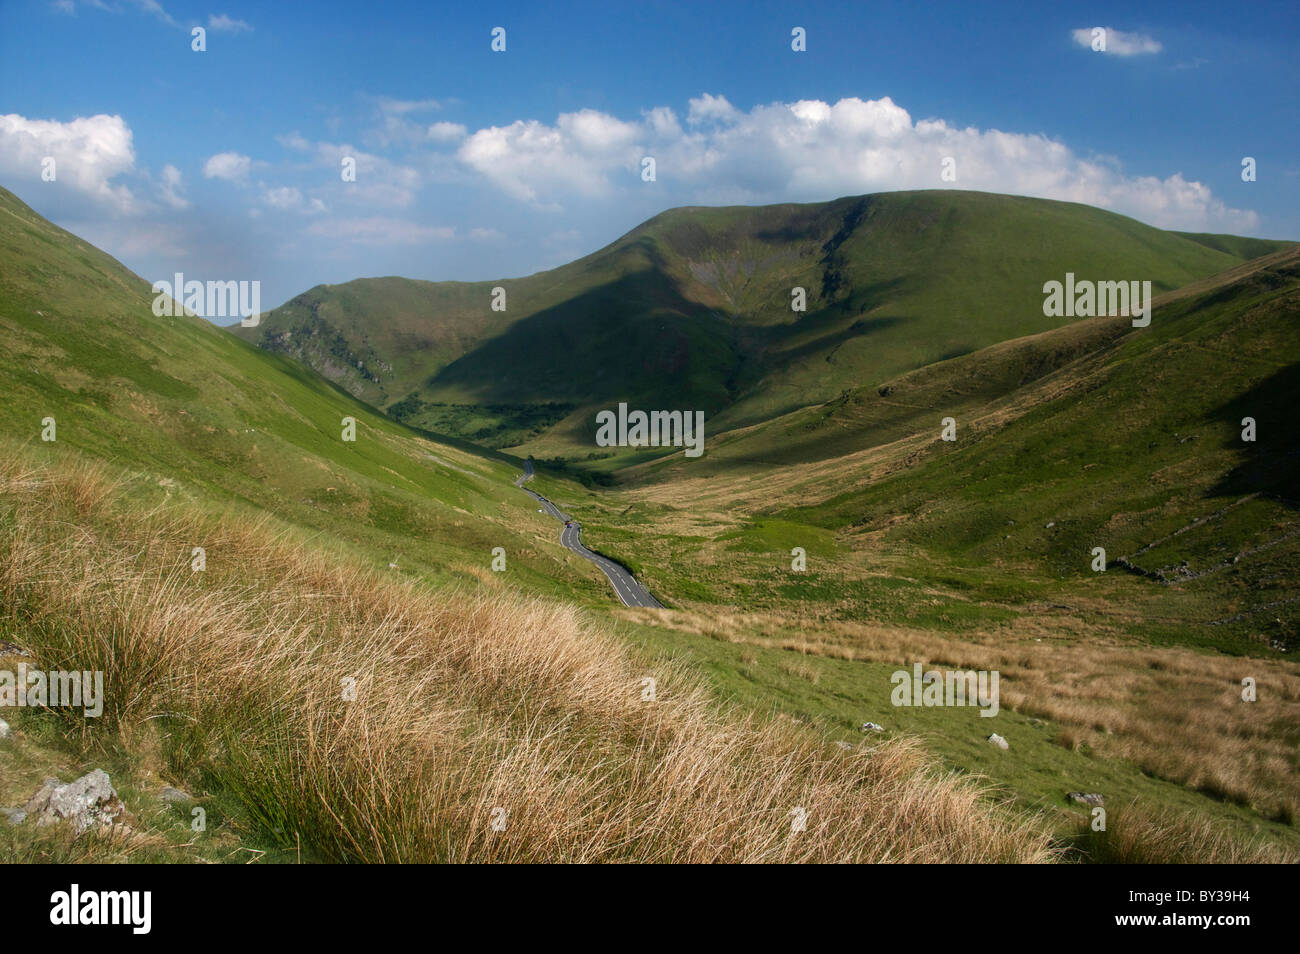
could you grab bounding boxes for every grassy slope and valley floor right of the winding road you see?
[525,248,1300,840]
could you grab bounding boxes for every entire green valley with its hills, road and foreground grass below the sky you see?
[0,180,1300,862]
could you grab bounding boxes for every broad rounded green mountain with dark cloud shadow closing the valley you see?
[235,191,1284,454]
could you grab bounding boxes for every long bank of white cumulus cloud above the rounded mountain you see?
[458,94,1258,231]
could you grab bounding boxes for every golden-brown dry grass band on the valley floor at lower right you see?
[641,611,1300,823]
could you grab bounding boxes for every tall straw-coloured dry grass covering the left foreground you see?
[0,455,1054,862]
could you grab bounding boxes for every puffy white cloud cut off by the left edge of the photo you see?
[0,113,140,213]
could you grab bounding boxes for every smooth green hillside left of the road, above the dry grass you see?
[0,190,605,599]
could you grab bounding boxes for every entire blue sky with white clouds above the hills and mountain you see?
[0,0,1300,314]
